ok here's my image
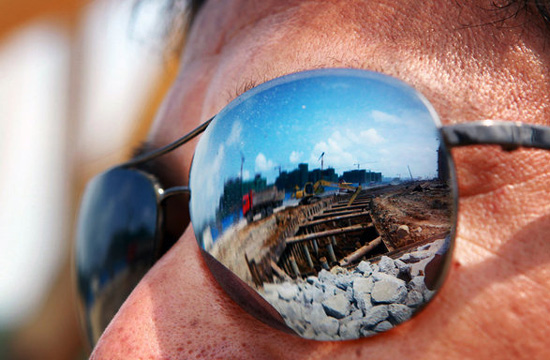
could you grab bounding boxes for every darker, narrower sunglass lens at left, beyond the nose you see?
[76,168,159,344]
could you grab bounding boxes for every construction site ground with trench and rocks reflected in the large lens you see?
[203,177,454,340]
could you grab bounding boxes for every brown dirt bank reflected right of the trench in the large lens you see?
[371,181,454,250]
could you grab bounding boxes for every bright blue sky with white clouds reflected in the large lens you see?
[191,70,440,231]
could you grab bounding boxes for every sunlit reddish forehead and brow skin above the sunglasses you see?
[147,0,550,150]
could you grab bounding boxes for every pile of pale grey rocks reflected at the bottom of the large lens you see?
[261,239,444,340]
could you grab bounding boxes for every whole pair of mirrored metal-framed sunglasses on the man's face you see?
[75,69,550,344]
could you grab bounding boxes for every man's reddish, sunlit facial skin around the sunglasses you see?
[94,0,550,359]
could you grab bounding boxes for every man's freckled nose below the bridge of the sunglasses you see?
[91,227,320,359]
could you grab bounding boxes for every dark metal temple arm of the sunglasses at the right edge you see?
[441,120,550,151]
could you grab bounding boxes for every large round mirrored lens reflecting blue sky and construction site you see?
[190,69,456,340]
